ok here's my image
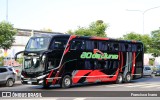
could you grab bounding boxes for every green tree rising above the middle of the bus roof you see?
[67,20,108,37]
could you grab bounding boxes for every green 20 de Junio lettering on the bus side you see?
[80,52,118,59]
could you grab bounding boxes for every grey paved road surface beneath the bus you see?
[0,77,160,100]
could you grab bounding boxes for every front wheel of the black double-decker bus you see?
[61,75,72,88]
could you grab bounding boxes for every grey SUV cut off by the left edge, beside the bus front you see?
[0,66,16,87]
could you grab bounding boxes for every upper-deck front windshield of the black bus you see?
[26,37,51,51]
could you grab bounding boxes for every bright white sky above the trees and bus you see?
[0,0,160,38]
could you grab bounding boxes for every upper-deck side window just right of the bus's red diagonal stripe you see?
[71,41,85,50]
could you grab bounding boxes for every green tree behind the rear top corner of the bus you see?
[121,32,152,53]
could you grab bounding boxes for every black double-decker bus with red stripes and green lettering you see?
[15,34,144,88]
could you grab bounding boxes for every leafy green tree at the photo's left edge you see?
[0,21,17,49]
